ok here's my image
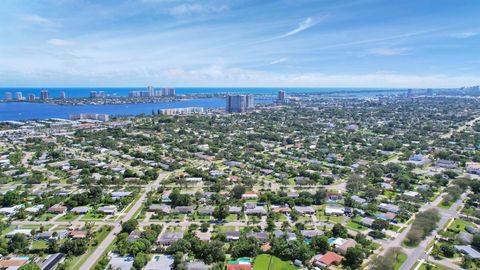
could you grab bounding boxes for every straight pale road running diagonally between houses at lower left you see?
[80,173,169,270]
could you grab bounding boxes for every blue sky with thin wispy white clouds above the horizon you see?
[0,0,480,88]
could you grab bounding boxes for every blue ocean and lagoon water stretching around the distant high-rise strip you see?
[0,87,405,121]
